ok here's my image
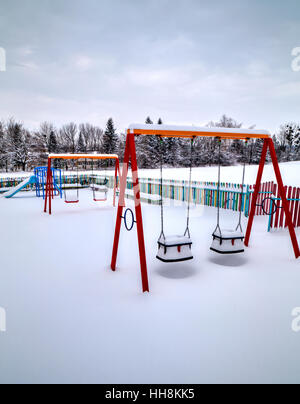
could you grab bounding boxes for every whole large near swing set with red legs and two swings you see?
[111,124,300,292]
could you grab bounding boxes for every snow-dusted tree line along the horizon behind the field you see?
[0,115,300,172]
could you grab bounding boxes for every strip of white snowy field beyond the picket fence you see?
[0,161,300,186]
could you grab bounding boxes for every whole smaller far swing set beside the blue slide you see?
[44,154,120,215]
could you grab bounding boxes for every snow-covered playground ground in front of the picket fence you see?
[0,188,300,383]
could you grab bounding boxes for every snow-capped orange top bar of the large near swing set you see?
[127,124,271,139]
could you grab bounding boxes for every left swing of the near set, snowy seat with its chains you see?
[156,138,194,263]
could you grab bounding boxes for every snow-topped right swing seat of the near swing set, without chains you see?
[210,229,245,254]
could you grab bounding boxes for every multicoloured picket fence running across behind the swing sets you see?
[0,173,300,230]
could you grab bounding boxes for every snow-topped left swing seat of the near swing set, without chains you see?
[156,236,194,262]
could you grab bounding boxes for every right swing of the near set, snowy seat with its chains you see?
[210,138,248,254]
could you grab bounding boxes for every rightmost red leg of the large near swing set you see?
[268,139,300,258]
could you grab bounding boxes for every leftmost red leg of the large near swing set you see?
[111,136,130,271]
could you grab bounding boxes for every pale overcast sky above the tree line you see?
[0,0,300,131]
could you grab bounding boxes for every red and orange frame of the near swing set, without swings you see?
[111,124,300,292]
